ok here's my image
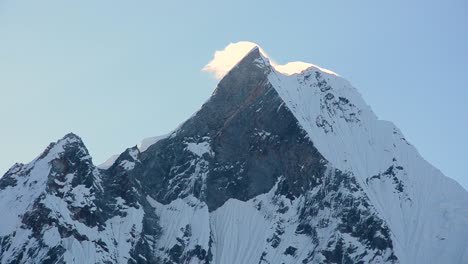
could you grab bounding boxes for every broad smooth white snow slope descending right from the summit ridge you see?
[249,46,468,263]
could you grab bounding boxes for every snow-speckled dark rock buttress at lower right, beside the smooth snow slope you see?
[296,170,397,263]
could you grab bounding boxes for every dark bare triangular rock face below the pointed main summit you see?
[134,50,324,210]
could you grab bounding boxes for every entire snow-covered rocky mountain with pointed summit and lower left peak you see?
[0,44,468,264]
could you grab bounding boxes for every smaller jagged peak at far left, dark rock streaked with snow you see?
[0,134,144,263]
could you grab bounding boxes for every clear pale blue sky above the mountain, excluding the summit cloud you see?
[0,0,468,188]
